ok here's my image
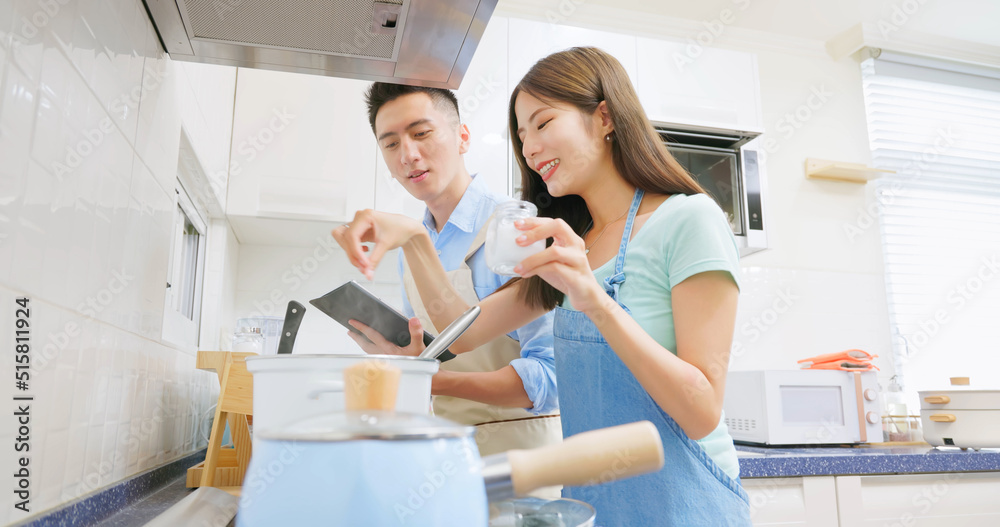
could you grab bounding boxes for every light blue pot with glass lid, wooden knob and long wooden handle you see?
[236,363,663,527]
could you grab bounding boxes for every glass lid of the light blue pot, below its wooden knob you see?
[258,410,476,442]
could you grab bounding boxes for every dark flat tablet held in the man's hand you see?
[309,280,455,362]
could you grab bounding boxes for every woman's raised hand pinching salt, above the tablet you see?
[331,209,424,280]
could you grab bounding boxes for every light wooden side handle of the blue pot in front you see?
[507,421,663,495]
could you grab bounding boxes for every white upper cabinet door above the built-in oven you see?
[636,37,762,131]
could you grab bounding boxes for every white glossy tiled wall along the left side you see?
[0,0,235,524]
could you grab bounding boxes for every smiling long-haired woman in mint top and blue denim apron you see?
[334,48,750,526]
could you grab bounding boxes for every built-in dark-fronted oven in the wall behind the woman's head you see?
[653,123,767,256]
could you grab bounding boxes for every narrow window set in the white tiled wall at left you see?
[163,184,206,347]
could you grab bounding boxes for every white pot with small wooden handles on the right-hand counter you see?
[917,386,1000,450]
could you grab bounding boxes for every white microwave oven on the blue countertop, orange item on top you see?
[723,370,882,445]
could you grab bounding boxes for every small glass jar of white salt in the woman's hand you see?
[486,201,545,275]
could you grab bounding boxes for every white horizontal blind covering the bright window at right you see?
[862,53,1000,392]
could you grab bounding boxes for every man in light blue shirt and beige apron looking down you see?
[334,82,562,455]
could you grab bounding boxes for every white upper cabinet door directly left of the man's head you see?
[226,68,376,222]
